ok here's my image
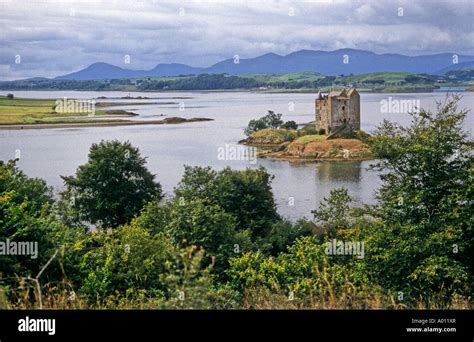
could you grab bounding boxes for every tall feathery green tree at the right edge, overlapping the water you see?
[367,96,474,300]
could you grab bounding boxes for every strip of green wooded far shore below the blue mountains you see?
[0,69,460,91]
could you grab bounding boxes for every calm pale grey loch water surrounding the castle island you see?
[0,91,474,219]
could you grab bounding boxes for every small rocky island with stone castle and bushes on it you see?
[240,88,372,160]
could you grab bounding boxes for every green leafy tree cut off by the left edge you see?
[0,160,58,284]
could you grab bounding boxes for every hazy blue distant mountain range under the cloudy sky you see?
[55,49,474,80]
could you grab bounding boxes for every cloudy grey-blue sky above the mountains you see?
[0,0,474,80]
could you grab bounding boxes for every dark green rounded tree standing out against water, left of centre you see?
[62,140,162,228]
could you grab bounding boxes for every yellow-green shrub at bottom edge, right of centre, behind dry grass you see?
[227,237,380,308]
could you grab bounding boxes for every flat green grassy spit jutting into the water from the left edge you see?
[0,96,132,125]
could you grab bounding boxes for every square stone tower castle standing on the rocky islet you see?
[315,88,360,134]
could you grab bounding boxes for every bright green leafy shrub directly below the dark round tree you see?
[79,224,178,303]
